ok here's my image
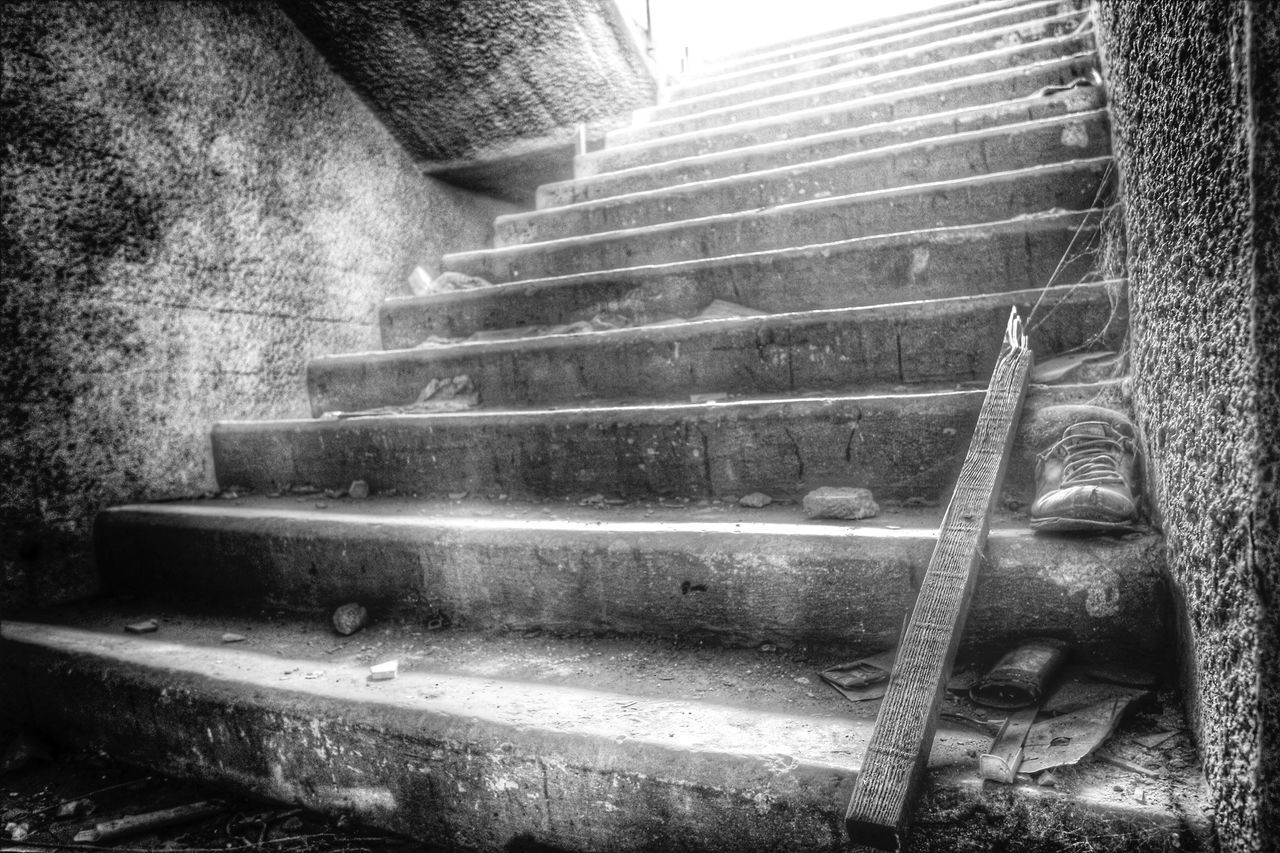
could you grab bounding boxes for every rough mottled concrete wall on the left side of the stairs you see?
[0,0,509,607]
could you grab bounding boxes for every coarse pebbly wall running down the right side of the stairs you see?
[1100,0,1280,850]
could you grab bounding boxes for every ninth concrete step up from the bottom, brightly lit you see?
[573,50,1098,178]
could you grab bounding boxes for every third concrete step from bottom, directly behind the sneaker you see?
[212,379,1119,503]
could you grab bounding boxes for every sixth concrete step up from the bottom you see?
[458,158,1114,275]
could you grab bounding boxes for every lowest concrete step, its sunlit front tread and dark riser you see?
[0,620,1203,852]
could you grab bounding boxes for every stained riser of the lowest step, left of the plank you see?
[0,642,856,853]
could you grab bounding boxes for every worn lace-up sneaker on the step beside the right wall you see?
[1032,420,1138,532]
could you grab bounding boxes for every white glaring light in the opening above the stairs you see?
[640,0,967,61]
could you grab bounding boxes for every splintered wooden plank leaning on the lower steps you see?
[845,309,1032,850]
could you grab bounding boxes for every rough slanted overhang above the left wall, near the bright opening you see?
[280,0,654,163]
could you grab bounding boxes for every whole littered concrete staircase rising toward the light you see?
[0,0,1203,850]
